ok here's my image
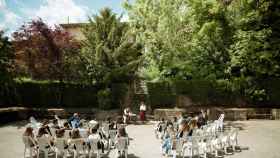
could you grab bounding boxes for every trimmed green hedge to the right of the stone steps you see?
[147,78,280,108]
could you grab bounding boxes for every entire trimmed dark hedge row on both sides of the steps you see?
[0,79,280,109]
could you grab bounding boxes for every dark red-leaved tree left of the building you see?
[12,19,80,81]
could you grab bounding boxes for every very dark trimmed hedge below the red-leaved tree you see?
[0,82,98,107]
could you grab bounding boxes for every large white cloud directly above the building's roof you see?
[25,0,88,25]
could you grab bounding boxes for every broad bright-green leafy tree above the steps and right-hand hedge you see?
[125,0,232,79]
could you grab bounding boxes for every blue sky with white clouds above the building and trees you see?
[0,0,127,34]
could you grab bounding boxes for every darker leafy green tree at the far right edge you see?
[228,0,280,101]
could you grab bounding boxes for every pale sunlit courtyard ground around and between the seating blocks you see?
[0,120,280,158]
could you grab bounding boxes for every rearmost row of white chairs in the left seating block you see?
[23,136,128,158]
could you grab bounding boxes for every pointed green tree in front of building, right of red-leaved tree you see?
[81,8,142,108]
